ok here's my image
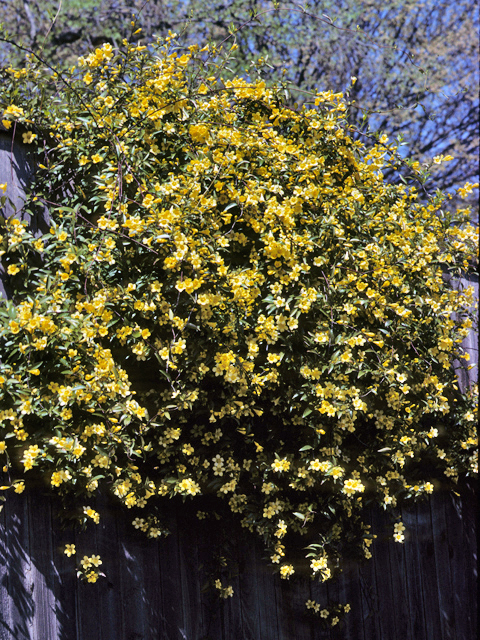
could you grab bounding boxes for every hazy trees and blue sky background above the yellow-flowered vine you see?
[0,0,479,205]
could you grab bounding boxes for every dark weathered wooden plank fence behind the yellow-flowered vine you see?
[0,127,478,640]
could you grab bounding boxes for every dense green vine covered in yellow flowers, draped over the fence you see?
[0,32,477,618]
